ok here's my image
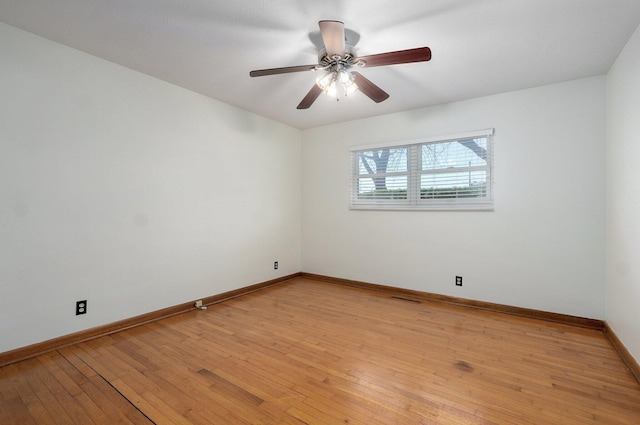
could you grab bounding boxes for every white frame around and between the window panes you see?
[349,128,494,211]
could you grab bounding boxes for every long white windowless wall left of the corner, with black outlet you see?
[0,23,301,352]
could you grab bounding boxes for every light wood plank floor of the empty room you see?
[0,278,640,425]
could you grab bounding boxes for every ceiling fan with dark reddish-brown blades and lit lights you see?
[249,21,431,109]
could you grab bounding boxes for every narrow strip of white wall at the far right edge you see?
[606,24,640,361]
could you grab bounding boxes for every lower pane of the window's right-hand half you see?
[420,170,487,199]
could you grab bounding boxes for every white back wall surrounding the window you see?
[302,77,605,319]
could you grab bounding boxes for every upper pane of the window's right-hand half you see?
[421,138,487,170]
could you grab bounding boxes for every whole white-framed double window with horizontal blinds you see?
[351,129,493,210]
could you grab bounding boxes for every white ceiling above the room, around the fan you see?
[0,0,640,128]
